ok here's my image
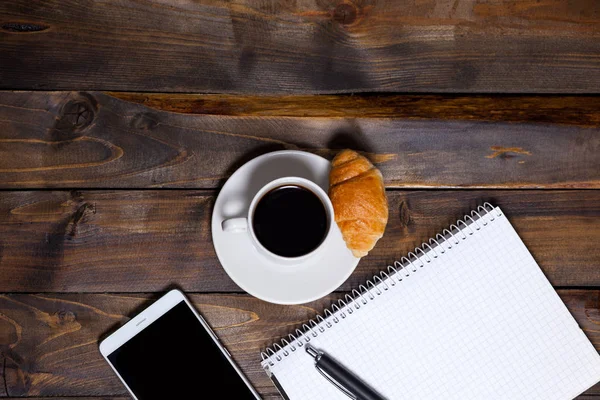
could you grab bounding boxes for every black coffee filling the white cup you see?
[252,185,329,257]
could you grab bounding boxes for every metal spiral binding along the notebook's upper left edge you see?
[260,202,502,366]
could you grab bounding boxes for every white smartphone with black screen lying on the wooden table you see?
[100,290,260,400]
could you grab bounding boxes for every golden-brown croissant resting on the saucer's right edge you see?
[329,150,388,257]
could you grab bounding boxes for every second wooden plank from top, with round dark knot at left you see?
[0,92,600,188]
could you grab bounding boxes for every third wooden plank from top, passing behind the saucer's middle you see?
[0,190,600,292]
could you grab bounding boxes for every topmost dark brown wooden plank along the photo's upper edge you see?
[0,0,600,93]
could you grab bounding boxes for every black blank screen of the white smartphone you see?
[108,301,256,400]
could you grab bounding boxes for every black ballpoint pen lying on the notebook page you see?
[306,345,385,400]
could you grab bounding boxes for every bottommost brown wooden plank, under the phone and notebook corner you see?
[0,290,600,399]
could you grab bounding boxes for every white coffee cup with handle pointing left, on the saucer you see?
[221,176,334,265]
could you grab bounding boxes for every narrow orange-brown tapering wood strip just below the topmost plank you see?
[107,92,600,127]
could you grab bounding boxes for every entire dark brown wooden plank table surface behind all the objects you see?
[0,0,600,400]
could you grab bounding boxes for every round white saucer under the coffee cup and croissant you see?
[212,150,360,304]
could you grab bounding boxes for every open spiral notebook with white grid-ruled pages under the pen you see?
[262,203,600,400]
